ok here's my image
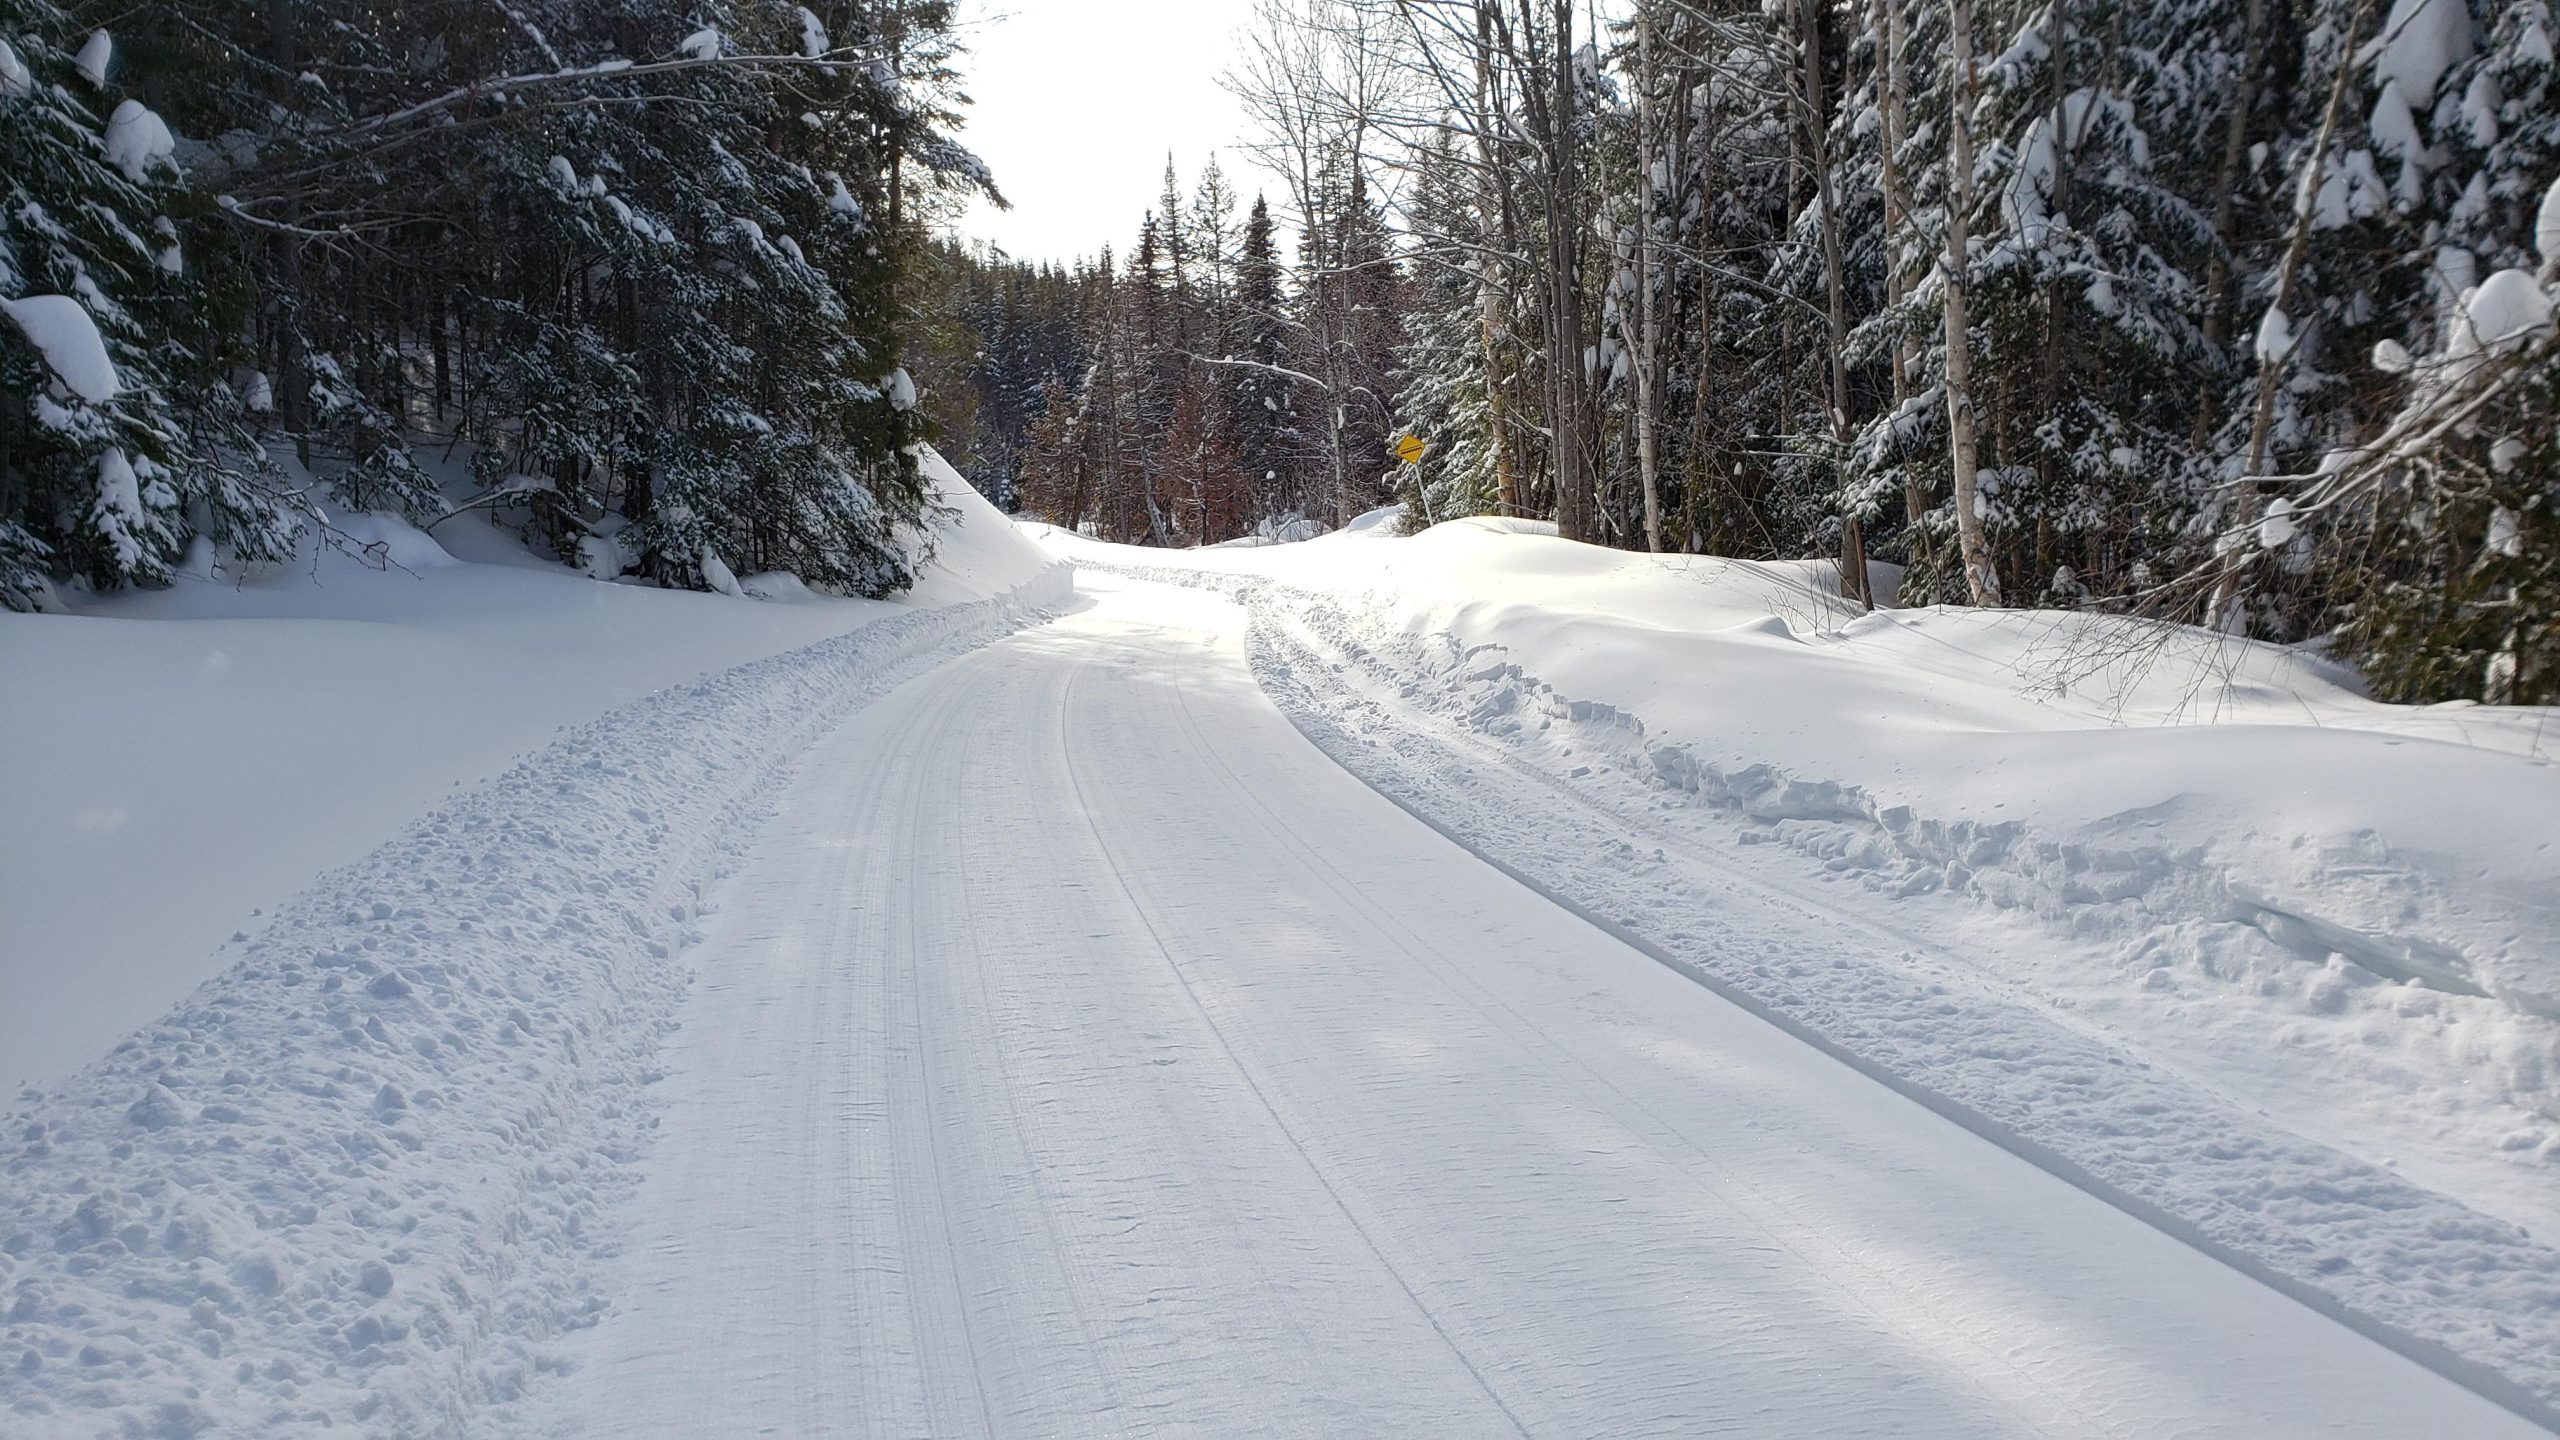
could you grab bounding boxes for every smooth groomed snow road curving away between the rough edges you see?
[509,579,2532,1435]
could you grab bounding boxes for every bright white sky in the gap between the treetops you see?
[960,0,1283,261]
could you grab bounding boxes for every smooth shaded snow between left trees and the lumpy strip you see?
[0,459,1042,1086]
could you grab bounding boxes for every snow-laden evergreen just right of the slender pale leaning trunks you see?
[1969,0,2214,605]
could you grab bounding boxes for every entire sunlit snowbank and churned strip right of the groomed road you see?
[1044,509,2560,1414]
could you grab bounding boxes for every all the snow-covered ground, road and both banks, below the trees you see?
[0,477,2560,1435]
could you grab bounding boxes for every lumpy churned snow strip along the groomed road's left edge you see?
[0,566,1073,1435]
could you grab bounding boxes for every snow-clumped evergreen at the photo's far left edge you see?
[0,12,294,610]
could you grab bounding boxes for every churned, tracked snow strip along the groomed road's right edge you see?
[1085,561,2560,1430]
